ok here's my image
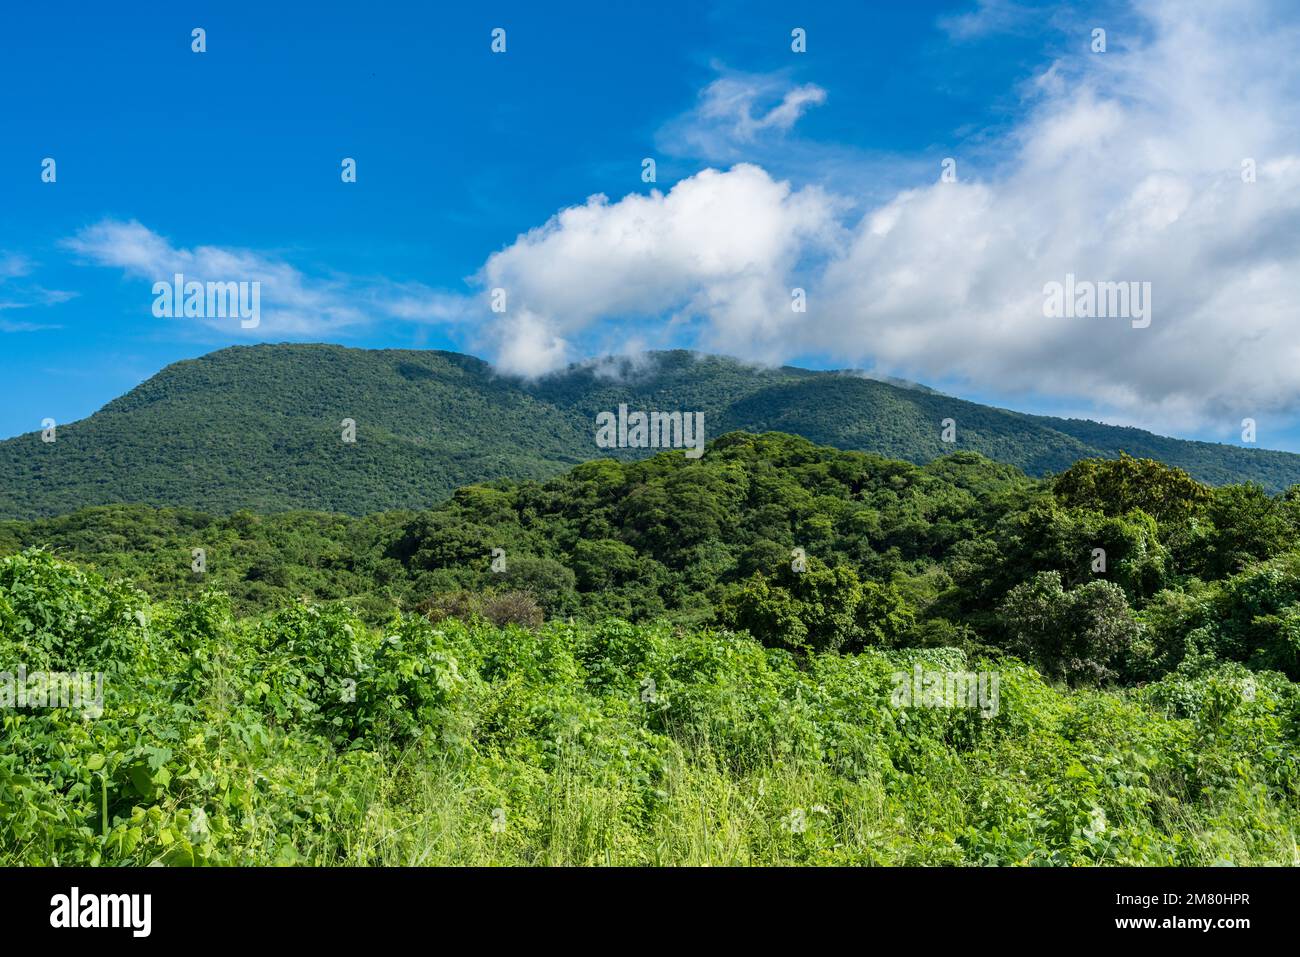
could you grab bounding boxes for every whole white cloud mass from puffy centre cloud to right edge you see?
[480,0,1300,429]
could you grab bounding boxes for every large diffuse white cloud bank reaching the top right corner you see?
[809,3,1300,428]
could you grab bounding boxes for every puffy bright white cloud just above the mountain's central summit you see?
[478,165,842,374]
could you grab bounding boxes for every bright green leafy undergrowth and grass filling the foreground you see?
[0,551,1300,866]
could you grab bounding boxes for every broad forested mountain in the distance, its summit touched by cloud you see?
[0,345,1300,518]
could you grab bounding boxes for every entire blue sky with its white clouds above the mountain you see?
[0,0,1300,449]
